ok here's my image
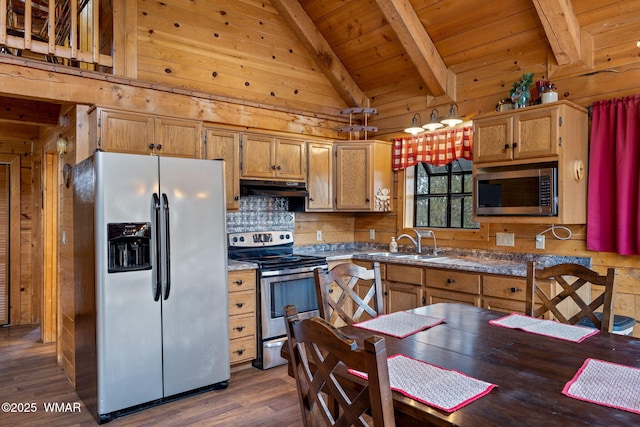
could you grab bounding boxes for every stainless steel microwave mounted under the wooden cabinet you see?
[475,167,558,216]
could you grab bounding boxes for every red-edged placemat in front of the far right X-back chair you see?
[489,313,599,342]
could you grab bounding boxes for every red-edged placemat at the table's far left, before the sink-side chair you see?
[353,311,444,338]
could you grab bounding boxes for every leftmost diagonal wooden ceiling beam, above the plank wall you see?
[271,0,369,107]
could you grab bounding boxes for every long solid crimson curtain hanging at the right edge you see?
[587,95,640,255]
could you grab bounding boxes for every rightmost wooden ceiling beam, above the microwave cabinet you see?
[533,0,593,68]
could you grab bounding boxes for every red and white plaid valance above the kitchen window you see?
[392,126,473,170]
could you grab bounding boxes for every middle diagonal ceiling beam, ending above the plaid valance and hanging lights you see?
[376,0,455,100]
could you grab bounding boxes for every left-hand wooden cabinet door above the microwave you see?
[473,116,513,165]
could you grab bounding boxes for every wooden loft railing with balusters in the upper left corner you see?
[0,0,113,71]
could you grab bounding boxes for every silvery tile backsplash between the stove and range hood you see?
[227,196,295,233]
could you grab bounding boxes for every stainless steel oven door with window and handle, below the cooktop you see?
[260,265,326,341]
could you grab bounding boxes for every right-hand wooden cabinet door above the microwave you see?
[513,107,558,159]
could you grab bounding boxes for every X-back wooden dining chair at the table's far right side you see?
[525,261,615,332]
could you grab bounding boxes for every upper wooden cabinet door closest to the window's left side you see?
[336,142,373,211]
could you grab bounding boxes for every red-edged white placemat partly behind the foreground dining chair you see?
[349,354,497,412]
